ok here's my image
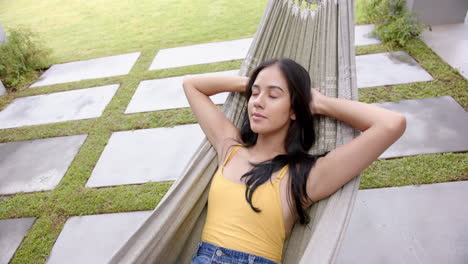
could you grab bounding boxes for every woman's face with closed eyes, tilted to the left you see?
[247,65,295,134]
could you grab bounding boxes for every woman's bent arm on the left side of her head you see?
[183,75,248,162]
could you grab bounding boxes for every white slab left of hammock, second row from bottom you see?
[86,124,204,187]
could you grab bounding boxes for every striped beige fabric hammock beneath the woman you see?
[110,0,360,264]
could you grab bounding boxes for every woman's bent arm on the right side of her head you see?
[307,90,406,202]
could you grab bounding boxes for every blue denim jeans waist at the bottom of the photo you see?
[191,241,278,264]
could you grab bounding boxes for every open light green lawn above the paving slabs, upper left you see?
[0,0,267,63]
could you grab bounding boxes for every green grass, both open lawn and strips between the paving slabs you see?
[0,0,468,263]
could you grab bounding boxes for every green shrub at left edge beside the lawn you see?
[0,27,50,92]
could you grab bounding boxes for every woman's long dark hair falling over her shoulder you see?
[240,59,319,224]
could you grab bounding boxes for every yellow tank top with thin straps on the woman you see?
[201,146,287,263]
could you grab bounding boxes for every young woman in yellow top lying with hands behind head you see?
[183,59,406,264]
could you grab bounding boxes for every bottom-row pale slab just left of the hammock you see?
[46,211,151,264]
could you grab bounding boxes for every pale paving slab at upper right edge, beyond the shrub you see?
[421,23,468,79]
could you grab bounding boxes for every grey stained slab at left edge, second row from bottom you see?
[0,135,87,195]
